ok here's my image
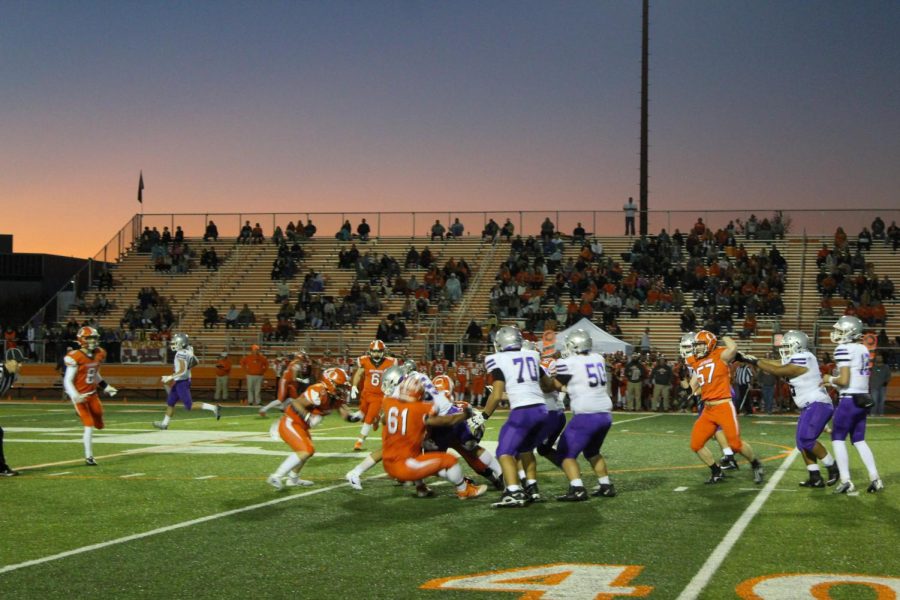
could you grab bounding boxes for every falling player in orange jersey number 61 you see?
[381,367,487,500]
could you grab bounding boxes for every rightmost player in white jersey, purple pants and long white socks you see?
[823,316,884,494]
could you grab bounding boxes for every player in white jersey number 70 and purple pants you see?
[469,327,553,507]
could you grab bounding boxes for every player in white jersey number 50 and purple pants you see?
[556,329,616,502]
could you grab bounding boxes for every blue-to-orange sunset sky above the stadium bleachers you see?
[0,0,900,256]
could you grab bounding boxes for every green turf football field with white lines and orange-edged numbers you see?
[0,402,900,600]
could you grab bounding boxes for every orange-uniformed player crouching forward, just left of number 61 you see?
[266,368,350,490]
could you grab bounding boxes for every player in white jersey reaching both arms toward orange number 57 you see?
[743,330,838,488]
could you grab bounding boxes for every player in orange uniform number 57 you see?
[686,330,764,483]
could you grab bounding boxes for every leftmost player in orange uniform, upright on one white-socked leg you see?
[63,327,118,467]
